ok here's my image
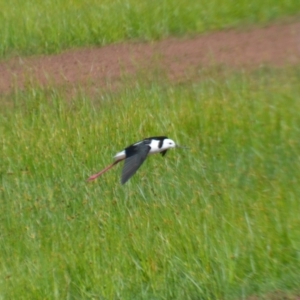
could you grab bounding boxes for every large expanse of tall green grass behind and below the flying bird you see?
[0,68,300,300]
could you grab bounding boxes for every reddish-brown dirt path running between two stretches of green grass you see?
[0,22,300,94]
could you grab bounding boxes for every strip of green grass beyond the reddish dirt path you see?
[0,0,300,58]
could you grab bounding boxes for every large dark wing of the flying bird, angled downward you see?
[121,143,151,184]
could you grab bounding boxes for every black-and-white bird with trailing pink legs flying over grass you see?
[88,136,185,184]
